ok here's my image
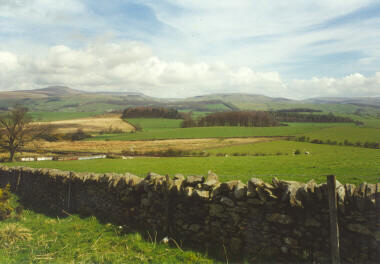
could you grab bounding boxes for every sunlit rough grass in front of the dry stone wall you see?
[0,196,215,263]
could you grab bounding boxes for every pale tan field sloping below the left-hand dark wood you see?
[35,115,134,134]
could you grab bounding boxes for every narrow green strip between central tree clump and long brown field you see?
[91,123,348,140]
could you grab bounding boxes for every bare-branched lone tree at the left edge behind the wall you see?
[0,106,33,162]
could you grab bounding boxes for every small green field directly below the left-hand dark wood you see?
[126,118,183,131]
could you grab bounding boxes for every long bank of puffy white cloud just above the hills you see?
[0,42,380,98]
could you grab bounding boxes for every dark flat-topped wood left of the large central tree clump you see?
[122,106,183,119]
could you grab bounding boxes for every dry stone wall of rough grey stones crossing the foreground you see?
[0,167,380,263]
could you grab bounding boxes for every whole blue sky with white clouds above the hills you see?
[0,0,380,99]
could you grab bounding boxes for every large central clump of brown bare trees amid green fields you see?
[181,111,280,127]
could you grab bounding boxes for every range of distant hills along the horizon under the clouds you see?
[0,86,380,116]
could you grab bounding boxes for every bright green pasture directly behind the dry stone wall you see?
[8,141,380,184]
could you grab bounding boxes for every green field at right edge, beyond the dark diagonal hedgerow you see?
[304,126,380,143]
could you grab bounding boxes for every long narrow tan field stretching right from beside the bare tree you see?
[28,138,276,154]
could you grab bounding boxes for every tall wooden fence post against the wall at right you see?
[327,175,340,264]
